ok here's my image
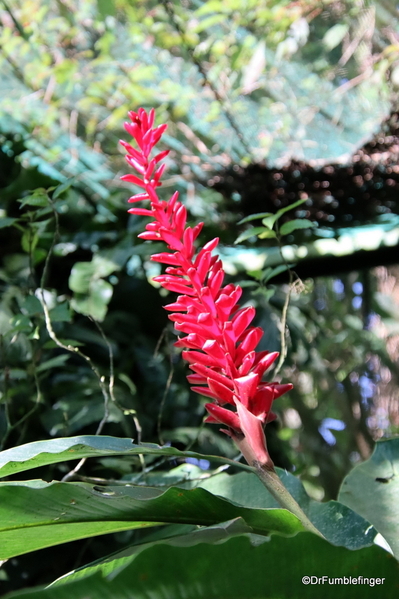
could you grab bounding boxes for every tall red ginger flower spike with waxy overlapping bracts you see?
[121,108,292,472]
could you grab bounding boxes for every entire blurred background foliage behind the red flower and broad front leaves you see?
[0,0,399,590]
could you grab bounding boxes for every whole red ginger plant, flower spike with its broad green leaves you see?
[0,109,399,599]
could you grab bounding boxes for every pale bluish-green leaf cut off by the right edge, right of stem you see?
[339,439,399,559]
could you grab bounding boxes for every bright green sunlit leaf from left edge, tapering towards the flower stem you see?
[0,480,303,559]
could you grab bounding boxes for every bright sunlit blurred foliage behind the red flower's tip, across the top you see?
[0,0,395,191]
